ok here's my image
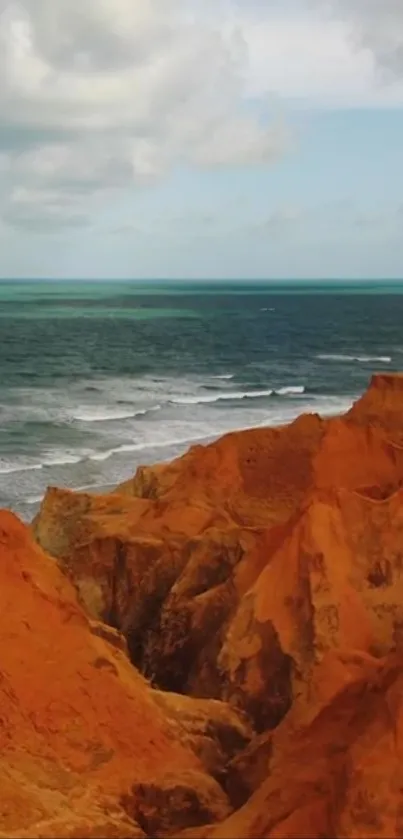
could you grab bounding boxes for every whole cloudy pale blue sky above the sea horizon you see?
[0,0,403,280]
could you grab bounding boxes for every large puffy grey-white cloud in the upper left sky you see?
[0,0,283,230]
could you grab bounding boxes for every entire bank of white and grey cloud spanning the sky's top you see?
[0,0,403,230]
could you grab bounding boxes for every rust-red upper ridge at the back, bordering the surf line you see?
[118,406,403,527]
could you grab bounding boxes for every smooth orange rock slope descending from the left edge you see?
[0,512,250,839]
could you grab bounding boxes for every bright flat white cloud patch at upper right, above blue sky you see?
[244,14,403,108]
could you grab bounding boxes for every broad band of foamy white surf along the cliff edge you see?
[0,365,352,516]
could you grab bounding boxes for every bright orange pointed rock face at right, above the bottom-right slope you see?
[218,482,403,728]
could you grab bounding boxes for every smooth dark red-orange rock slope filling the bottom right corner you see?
[180,654,403,839]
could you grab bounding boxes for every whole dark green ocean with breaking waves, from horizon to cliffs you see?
[0,281,403,520]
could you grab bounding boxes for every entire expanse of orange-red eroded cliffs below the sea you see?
[0,373,403,839]
